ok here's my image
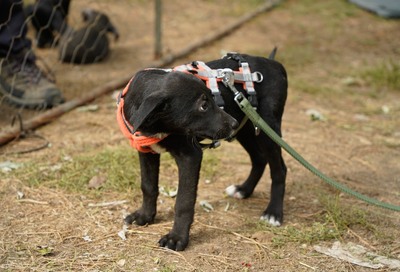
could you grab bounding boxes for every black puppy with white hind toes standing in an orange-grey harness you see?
[121,55,287,250]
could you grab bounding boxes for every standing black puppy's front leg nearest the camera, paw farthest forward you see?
[159,143,203,251]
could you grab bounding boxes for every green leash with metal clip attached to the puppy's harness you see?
[219,69,400,212]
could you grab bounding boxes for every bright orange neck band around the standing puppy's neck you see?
[117,78,167,153]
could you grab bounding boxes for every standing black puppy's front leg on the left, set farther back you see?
[125,153,160,226]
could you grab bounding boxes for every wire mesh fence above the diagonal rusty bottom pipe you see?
[0,0,272,149]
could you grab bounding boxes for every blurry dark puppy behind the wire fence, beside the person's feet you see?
[59,9,119,64]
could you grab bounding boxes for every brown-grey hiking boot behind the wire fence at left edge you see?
[0,51,64,109]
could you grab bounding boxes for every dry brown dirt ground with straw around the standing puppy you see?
[0,0,400,271]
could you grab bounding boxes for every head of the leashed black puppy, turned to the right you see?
[125,70,238,139]
